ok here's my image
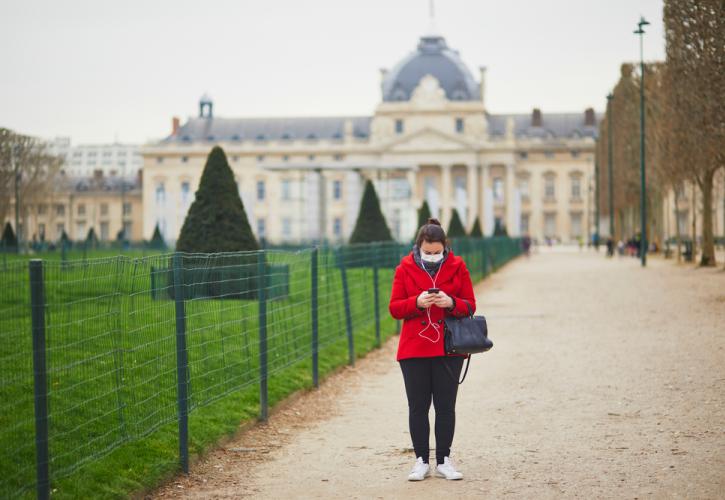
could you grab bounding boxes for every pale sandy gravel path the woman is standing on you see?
[150,250,725,499]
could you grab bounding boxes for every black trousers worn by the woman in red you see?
[400,356,465,464]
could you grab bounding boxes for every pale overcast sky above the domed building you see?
[0,0,664,144]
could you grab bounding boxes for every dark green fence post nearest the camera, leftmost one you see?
[29,259,50,500]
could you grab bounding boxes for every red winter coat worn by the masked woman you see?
[388,249,476,361]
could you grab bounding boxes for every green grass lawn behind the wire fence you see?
[0,240,514,498]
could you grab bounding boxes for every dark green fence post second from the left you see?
[171,252,189,474]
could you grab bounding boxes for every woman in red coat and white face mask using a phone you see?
[389,219,476,481]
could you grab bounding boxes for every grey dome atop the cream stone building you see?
[383,34,481,101]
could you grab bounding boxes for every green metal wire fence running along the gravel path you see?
[0,238,520,498]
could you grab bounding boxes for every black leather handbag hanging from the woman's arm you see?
[443,299,493,384]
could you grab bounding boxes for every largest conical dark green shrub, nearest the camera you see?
[176,146,259,253]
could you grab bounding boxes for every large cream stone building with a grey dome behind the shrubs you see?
[141,30,596,243]
